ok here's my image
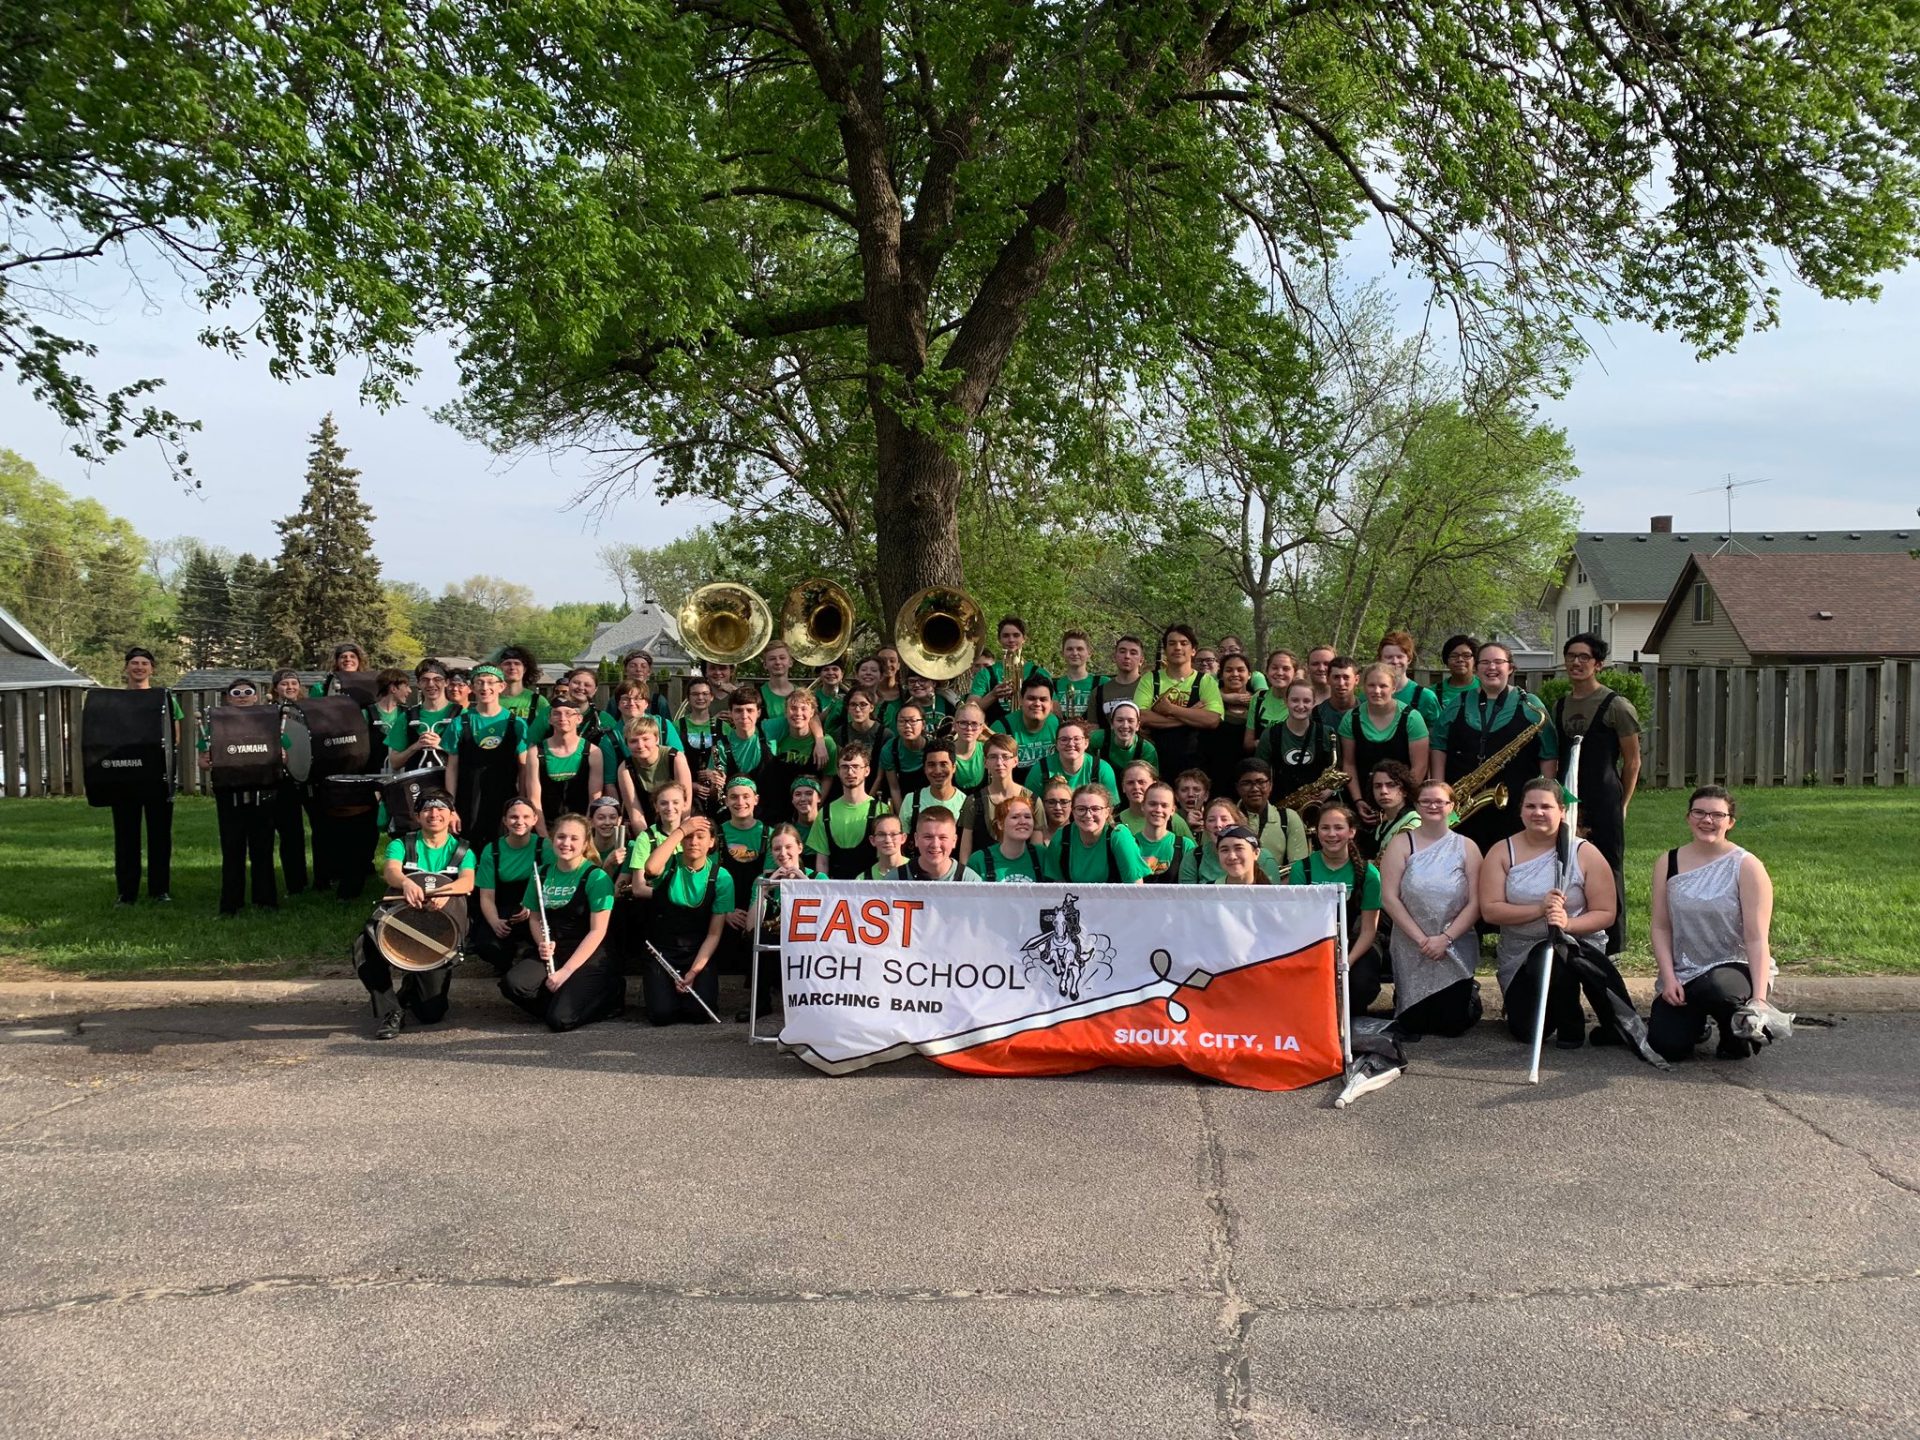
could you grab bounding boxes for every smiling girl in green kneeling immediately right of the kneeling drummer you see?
[499,814,626,1031]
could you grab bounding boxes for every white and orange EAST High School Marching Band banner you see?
[762,879,1344,1091]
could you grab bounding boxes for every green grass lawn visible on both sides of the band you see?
[0,789,1920,979]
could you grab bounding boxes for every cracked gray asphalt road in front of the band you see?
[0,985,1920,1440]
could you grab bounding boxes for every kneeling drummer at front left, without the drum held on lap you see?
[353,791,474,1041]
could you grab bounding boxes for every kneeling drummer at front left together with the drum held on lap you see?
[353,791,474,1041]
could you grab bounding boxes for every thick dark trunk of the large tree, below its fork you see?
[874,407,966,639]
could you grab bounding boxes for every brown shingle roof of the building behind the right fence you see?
[1647,553,1920,659]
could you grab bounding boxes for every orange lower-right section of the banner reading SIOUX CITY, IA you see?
[929,939,1342,1091]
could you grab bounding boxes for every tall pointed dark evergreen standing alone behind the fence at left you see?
[267,415,386,664]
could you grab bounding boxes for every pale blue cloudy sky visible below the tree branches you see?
[0,236,1920,605]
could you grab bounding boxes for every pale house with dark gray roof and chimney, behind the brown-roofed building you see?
[1542,515,1920,664]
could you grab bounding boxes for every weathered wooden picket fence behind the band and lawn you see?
[0,660,1920,797]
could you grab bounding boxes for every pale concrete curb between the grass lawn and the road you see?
[0,973,1920,1020]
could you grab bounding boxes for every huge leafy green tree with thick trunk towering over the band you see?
[0,0,1920,625]
